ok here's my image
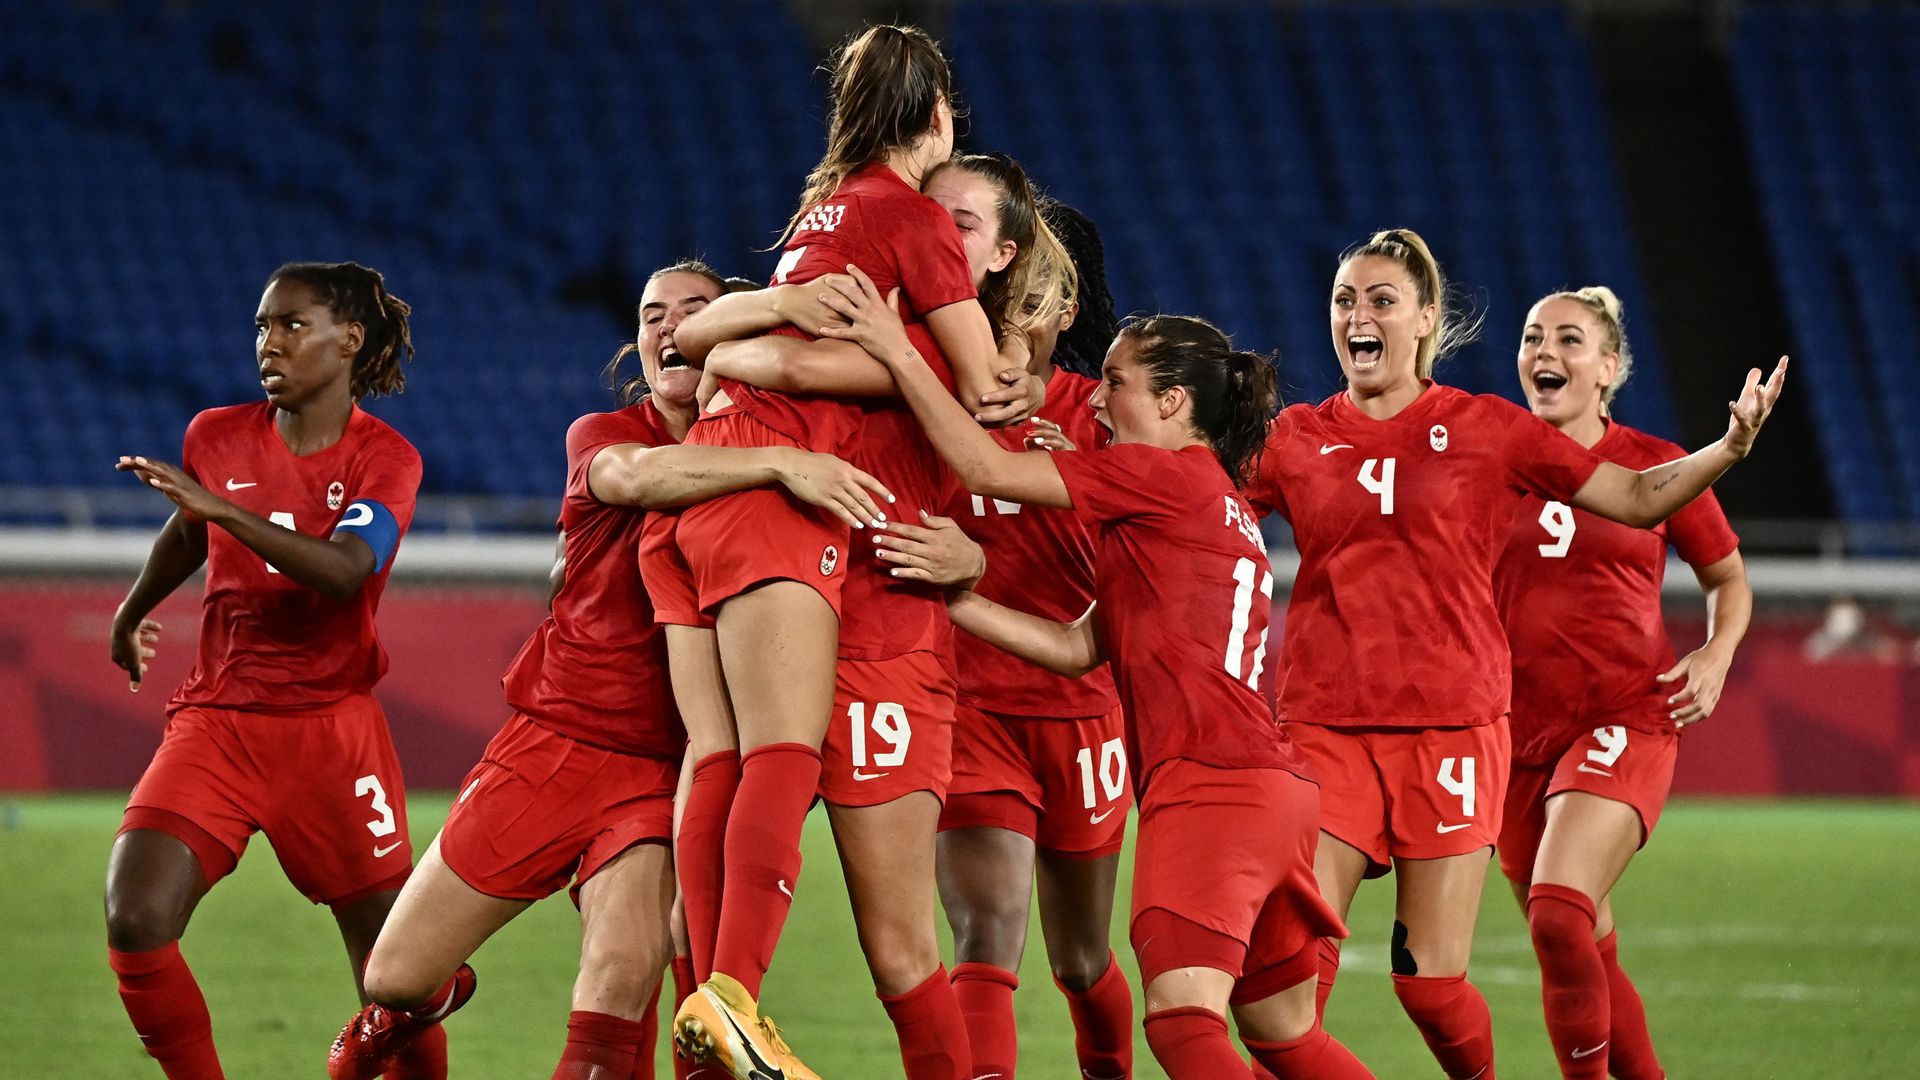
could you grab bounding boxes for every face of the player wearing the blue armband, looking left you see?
[253,281,365,413]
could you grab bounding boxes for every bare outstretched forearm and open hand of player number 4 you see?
[1572,356,1788,528]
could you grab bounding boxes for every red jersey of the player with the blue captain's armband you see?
[167,402,420,713]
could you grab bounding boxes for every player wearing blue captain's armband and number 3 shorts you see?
[106,263,432,1080]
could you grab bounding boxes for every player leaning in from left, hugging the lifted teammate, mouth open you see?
[328,261,890,1080]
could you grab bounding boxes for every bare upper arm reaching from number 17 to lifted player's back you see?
[822,267,1073,509]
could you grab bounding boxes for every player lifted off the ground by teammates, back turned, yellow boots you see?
[649,27,1037,1078]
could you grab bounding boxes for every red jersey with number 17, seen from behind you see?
[1054,442,1306,794]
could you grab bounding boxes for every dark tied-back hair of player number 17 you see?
[1119,315,1281,486]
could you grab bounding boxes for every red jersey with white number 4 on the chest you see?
[1246,382,1601,726]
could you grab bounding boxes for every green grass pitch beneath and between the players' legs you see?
[0,796,1920,1080]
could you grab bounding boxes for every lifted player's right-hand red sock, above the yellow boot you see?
[714,742,820,997]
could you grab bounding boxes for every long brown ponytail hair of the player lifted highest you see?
[780,27,962,244]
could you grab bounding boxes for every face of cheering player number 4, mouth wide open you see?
[1327,256,1438,394]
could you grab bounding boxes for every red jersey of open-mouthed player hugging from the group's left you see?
[501,402,685,761]
